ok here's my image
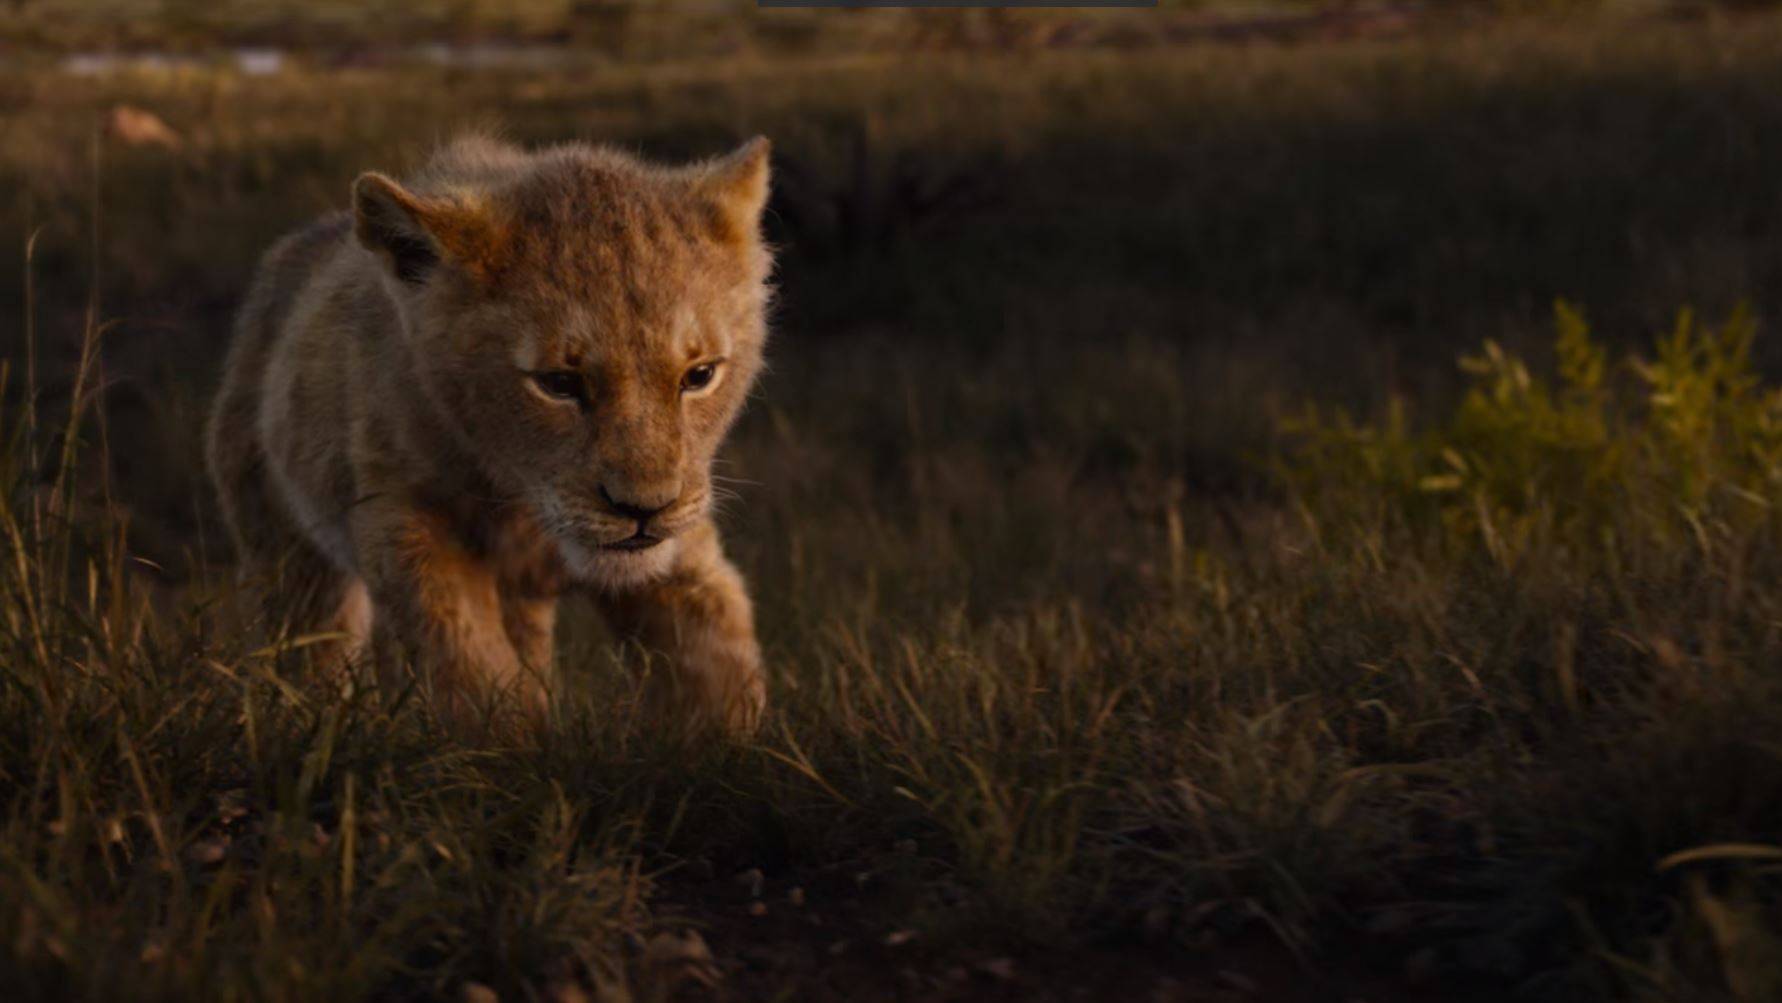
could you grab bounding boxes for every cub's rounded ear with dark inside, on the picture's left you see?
[353,171,497,285]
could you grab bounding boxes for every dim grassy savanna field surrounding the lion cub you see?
[0,0,1782,1003]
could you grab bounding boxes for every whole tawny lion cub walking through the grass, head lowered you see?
[207,137,772,734]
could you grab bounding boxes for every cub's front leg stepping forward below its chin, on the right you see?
[595,522,766,738]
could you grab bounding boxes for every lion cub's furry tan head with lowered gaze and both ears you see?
[353,139,772,584]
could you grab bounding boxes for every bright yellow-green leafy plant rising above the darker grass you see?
[1279,303,1782,568]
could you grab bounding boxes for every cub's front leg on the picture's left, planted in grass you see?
[353,497,549,734]
